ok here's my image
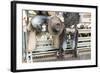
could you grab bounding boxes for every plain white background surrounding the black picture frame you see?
[0,0,100,73]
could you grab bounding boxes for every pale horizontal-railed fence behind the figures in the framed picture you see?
[24,29,91,62]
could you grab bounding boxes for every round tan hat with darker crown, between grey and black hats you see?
[48,16,64,35]
